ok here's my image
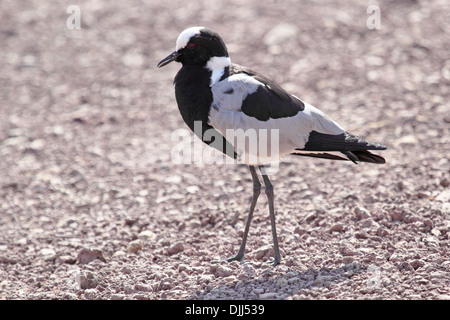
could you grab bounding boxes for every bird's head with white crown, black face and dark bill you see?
[158,27,228,68]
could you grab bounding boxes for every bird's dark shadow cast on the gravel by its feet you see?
[187,262,371,300]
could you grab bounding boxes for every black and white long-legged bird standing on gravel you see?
[157,27,386,265]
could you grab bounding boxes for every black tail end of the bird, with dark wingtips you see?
[292,131,386,164]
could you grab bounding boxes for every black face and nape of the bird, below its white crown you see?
[176,29,228,65]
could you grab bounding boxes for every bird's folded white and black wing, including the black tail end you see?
[209,65,386,163]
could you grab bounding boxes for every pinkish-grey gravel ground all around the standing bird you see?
[0,0,450,299]
